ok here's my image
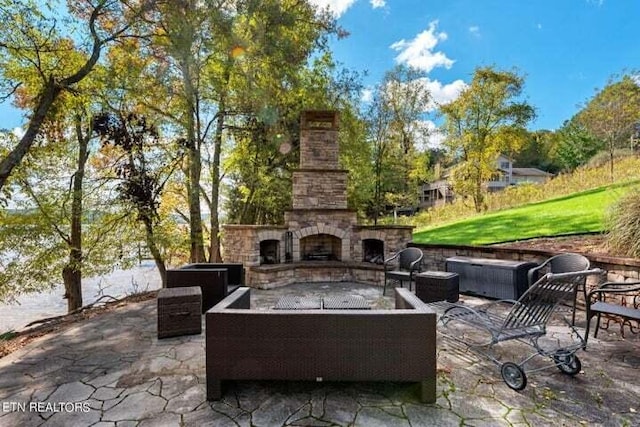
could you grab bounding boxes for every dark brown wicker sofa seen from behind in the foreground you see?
[206,288,436,401]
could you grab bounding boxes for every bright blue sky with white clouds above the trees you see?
[312,0,640,130]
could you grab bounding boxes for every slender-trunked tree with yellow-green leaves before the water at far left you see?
[0,117,135,312]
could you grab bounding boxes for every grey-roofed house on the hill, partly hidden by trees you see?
[419,154,553,209]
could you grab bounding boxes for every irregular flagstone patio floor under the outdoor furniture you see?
[0,283,640,426]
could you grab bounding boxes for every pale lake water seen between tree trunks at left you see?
[0,261,161,334]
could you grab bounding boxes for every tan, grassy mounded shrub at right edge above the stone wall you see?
[608,190,640,257]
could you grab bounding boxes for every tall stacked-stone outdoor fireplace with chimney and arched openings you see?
[222,111,413,288]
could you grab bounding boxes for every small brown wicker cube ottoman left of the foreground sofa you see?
[158,286,202,338]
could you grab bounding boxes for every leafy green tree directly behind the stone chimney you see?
[224,55,368,224]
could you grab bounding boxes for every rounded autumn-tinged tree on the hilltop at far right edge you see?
[576,75,640,181]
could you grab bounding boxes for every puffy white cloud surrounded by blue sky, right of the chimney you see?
[391,21,453,72]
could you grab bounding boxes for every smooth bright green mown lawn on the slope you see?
[413,181,640,245]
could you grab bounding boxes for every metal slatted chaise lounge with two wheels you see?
[440,269,603,390]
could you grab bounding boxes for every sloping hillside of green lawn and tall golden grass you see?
[414,158,640,245]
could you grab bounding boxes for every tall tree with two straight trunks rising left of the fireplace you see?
[139,0,335,261]
